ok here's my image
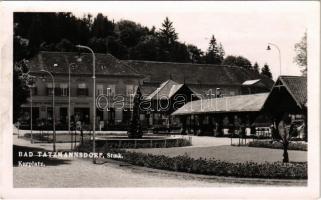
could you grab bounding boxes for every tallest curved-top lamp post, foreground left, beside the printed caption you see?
[76,45,96,164]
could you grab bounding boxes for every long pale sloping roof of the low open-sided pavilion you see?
[172,93,269,115]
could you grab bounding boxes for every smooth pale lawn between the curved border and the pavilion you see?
[129,145,307,163]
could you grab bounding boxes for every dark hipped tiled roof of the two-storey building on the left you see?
[28,51,142,76]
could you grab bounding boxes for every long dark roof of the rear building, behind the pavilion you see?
[123,60,274,89]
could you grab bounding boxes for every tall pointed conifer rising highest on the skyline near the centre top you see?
[159,17,178,47]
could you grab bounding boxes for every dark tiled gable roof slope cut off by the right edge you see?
[279,76,307,106]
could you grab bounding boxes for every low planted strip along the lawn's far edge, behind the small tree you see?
[248,140,308,151]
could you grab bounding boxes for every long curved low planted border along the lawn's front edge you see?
[109,150,307,179]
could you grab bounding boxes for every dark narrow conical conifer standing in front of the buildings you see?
[127,87,143,138]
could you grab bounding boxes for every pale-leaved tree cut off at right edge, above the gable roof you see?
[294,32,307,76]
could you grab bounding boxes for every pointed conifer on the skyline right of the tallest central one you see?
[204,35,224,64]
